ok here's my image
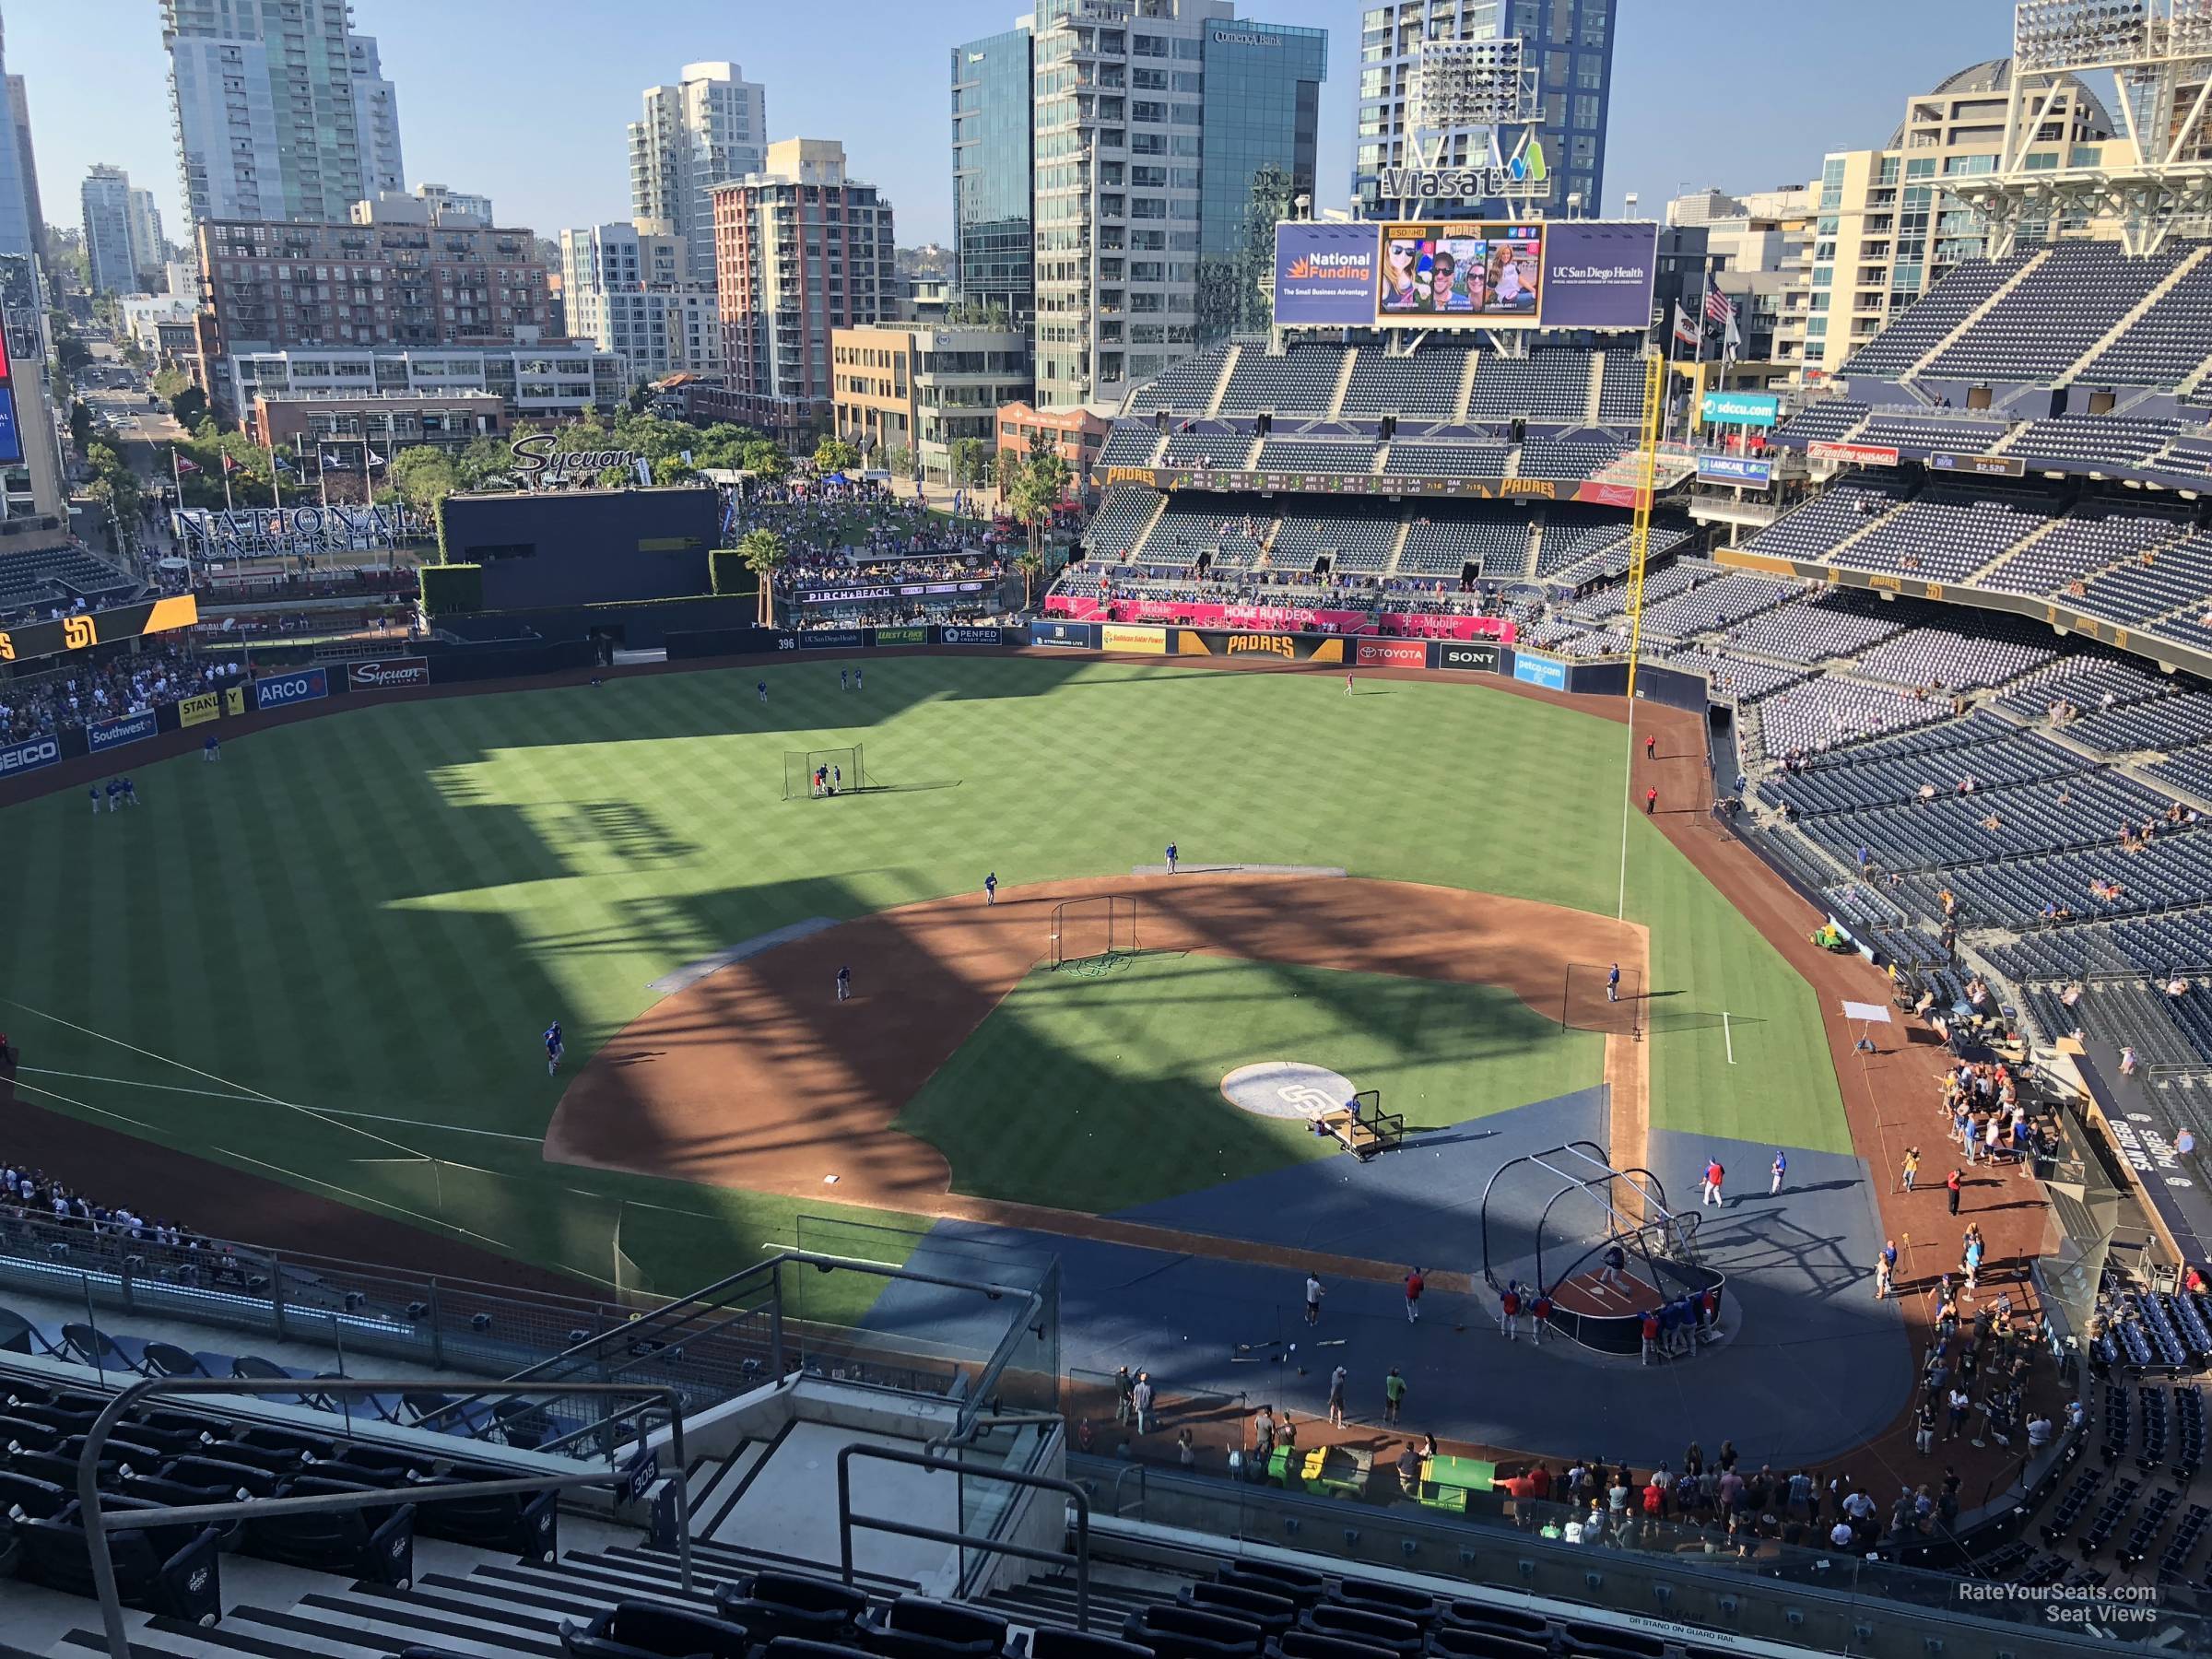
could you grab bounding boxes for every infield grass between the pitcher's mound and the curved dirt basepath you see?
[898,953,1606,1215]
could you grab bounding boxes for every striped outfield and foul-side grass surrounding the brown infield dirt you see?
[0,657,1847,1288]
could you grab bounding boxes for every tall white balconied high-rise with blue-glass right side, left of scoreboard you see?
[1008,0,1327,407]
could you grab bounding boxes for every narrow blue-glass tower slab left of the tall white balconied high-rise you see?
[953,24,1038,330]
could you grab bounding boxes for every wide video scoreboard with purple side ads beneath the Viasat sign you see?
[1274,219,1659,330]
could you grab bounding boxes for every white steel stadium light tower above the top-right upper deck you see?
[1945,0,2212,256]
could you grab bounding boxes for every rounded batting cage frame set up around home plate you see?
[1482,1141,1725,1354]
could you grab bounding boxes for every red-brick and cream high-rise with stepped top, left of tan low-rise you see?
[695,139,898,433]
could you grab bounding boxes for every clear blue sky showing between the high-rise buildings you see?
[13,0,2011,245]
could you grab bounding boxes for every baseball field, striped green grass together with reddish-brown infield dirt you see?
[0,654,1849,1294]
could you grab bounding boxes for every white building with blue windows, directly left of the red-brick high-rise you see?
[559,219,721,385]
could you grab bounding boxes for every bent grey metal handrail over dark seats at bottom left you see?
[77,1376,692,1659]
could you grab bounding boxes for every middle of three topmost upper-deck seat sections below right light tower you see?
[1915,241,2181,381]
